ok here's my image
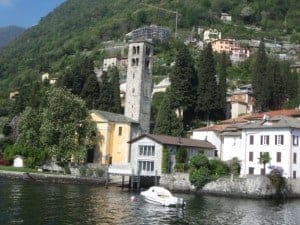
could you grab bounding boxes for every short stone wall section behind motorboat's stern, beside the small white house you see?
[159,173,194,192]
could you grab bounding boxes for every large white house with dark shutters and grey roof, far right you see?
[241,116,300,178]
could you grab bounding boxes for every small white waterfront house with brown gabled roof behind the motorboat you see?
[129,134,215,176]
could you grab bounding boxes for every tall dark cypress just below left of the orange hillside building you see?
[196,43,220,120]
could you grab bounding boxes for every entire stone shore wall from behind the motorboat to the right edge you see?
[160,173,300,198]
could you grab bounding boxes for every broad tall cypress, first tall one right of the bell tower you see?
[170,44,197,123]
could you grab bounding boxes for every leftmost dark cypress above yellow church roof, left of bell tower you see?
[81,74,100,109]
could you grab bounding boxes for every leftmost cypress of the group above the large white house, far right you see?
[252,41,268,111]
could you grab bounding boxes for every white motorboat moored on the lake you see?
[141,186,185,206]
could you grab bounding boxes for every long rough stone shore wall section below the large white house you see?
[199,176,276,198]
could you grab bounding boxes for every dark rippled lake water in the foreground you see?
[0,178,300,225]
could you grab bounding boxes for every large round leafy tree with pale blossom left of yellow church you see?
[39,88,91,163]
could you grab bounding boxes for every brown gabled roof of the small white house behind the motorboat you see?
[129,134,216,149]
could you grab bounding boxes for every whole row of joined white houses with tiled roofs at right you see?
[192,114,300,178]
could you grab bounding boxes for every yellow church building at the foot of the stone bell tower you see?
[88,110,139,164]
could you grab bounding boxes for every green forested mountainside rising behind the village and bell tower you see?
[0,0,300,96]
